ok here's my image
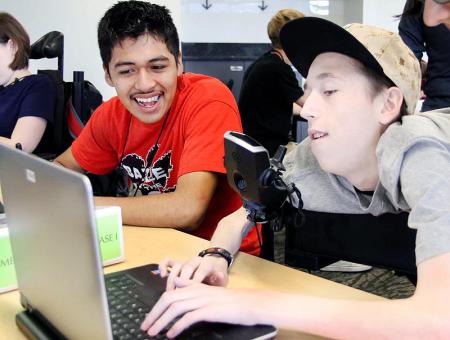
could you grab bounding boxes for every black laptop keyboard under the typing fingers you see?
[105,274,209,340]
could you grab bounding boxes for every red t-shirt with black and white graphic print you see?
[72,73,259,254]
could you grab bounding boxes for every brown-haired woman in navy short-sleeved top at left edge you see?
[0,12,56,152]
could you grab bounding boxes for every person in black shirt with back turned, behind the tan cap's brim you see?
[238,9,304,156]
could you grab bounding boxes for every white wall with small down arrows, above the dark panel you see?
[180,0,362,43]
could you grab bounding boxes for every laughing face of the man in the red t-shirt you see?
[105,34,182,123]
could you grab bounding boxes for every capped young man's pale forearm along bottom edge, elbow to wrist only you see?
[259,292,450,339]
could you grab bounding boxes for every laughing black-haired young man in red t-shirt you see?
[56,1,259,253]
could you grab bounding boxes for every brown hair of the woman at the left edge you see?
[0,12,31,71]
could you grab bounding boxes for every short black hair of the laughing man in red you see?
[98,1,180,70]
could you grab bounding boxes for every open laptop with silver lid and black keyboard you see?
[0,145,276,340]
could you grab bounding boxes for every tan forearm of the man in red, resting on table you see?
[95,192,206,231]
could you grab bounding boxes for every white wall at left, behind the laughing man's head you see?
[0,0,180,99]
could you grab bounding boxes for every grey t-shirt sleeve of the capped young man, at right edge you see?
[400,140,450,263]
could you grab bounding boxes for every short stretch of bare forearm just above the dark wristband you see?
[210,207,247,254]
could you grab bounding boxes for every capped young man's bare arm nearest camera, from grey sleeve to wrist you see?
[264,253,450,339]
